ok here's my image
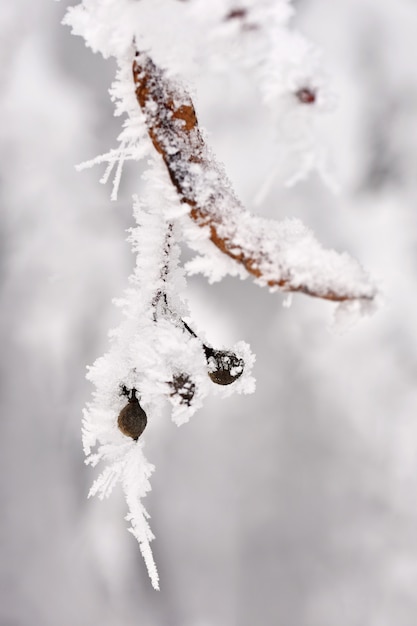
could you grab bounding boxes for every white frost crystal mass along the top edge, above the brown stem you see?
[64,0,335,190]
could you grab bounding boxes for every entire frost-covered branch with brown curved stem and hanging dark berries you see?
[65,0,376,589]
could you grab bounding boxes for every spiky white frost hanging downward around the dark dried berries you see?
[83,157,254,589]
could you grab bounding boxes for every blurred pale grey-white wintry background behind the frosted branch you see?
[0,0,417,626]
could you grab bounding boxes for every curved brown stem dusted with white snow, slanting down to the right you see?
[133,52,377,302]
